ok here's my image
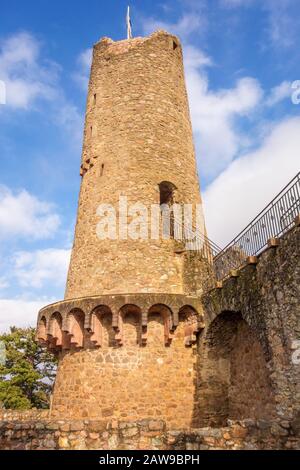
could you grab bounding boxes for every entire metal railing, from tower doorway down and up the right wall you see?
[163,172,300,286]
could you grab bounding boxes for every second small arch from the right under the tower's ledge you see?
[147,304,173,346]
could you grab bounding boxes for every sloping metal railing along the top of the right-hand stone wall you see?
[214,172,300,280]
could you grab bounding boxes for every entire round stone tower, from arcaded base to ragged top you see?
[37,31,209,427]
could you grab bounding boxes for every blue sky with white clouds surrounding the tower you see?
[0,0,300,330]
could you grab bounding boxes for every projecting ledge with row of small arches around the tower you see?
[36,294,204,352]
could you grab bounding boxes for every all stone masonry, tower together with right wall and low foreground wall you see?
[0,31,300,450]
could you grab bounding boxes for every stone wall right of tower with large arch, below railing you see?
[194,226,300,427]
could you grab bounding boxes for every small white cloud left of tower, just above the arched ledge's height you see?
[13,248,70,289]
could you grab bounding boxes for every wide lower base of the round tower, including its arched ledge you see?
[37,294,204,428]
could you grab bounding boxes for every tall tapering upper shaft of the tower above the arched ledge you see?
[66,32,205,299]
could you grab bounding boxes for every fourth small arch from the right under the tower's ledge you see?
[90,305,115,348]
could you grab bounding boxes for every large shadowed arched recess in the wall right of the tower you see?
[196,311,275,426]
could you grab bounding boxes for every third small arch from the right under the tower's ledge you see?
[116,304,142,347]
